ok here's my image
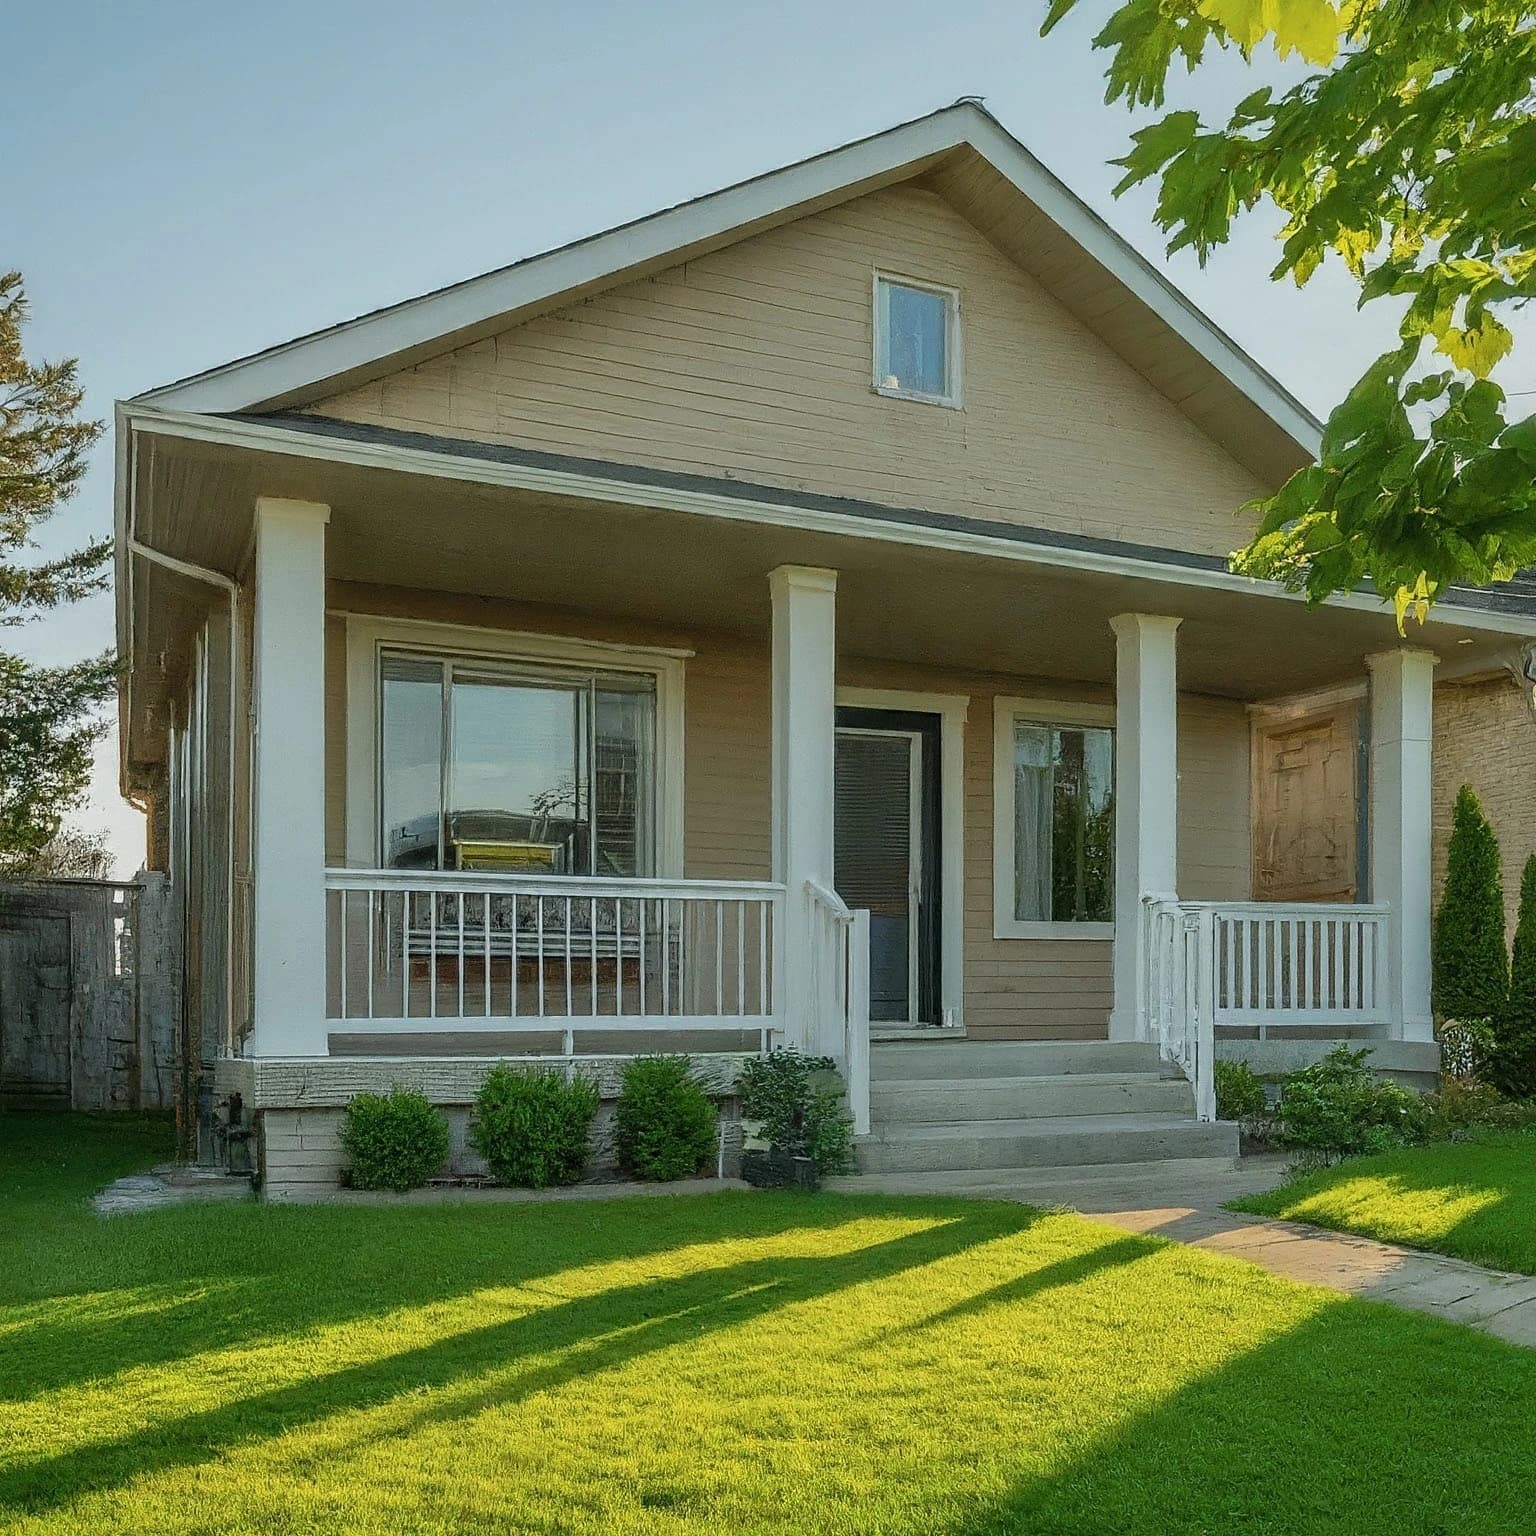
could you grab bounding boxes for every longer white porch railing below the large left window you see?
[326,869,785,1054]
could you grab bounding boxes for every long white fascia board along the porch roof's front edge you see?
[126,402,1536,636]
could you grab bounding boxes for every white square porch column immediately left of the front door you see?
[768,565,842,1054]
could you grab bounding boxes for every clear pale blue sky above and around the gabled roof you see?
[9,0,1425,872]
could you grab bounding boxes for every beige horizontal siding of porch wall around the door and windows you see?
[317,584,1249,1040]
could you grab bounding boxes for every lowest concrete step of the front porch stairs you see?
[854,1114,1238,1174]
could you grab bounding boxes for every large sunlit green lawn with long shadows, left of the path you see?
[0,1117,1536,1536]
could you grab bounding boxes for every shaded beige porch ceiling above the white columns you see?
[134,423,1508,768]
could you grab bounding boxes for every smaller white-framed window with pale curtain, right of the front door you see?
[994,699,1115,938]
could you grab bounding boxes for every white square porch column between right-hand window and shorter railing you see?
[1109,613,1180,1040]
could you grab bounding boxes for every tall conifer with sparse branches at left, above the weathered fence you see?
[0,272,115,856]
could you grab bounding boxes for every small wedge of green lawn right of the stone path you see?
[1232,1132,1536,1275]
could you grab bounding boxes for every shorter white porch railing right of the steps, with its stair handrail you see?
[1143,895,1392,1120]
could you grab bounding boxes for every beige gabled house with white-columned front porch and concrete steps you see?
[117,101,1536,1193]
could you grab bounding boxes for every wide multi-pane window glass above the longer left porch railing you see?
[379,650,657,879]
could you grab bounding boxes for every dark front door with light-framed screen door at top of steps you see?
[834,708,938,1025]
